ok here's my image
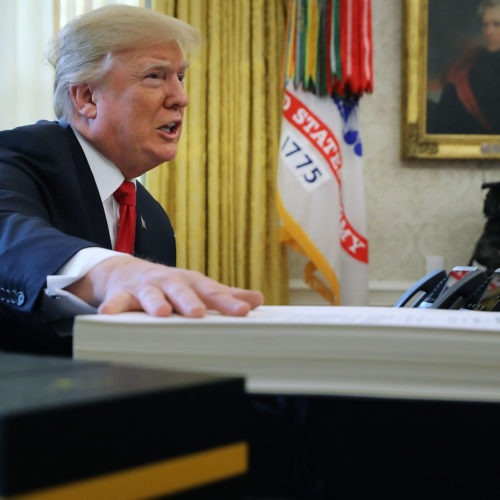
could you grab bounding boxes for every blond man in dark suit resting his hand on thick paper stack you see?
[0,5,263,355]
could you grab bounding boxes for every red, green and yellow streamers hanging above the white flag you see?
[284,0,373,97]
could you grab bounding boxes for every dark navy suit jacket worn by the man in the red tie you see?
[0,121,176,354]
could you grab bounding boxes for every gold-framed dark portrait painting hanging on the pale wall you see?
[402,0,500,160]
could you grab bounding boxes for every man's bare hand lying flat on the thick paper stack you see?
[67,255,264,318]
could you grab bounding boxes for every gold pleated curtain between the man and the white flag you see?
[146,0,288,304]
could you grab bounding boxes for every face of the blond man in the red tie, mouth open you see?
[91,42,188,178]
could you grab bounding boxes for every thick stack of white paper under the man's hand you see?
[74,306,500,401]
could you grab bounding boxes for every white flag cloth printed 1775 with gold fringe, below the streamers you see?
[278,84,368,305]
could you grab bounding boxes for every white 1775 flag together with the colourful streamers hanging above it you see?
[278,0,373,305]
